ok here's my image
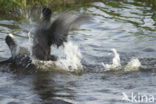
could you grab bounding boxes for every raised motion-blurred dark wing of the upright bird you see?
[50,13,90,47]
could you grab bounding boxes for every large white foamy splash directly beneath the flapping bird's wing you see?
[33,42,83,72]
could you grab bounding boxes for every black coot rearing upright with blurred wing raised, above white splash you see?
[32,8,90,61]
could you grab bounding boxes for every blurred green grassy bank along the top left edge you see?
[0,0,100,20]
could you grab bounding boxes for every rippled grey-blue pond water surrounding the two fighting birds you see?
[0,0,156,104]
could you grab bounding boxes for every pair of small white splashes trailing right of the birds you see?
[102,49,141,72]
